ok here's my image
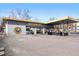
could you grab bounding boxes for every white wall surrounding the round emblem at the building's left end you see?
[6,24,26,35]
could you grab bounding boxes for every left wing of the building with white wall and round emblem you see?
[3,18,45,34]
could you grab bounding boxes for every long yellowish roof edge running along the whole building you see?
[3,16,79,24]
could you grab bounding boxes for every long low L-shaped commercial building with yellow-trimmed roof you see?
[2,16,79,34]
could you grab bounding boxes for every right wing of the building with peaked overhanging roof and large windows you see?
[48,17,79,32]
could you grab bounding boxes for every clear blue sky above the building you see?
[0,3,79,21]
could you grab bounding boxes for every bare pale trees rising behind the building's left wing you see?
[9,9,31,20]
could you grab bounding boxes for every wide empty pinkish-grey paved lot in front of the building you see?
[3,34,79,56]
